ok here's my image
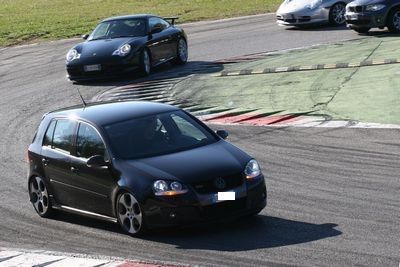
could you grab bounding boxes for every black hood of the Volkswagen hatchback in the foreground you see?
[123,140,251,184]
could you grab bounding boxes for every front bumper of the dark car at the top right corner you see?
[345,9,386,29]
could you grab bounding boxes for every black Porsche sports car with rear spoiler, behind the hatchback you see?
[66,15,188,81]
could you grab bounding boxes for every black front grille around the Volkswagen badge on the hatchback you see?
[192,173,244,194]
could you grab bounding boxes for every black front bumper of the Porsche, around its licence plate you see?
[66,53,140,81]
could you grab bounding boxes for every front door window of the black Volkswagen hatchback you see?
[76,123,105,159]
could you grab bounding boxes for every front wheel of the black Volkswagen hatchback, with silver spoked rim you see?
[116,191,147,237]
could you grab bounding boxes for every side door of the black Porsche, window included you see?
[148,17,173,65]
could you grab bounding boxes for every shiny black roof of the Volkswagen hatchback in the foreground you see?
[48,101,180,126]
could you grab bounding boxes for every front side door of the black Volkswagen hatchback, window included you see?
[71,122,117,216]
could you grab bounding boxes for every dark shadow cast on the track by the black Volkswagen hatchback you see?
[50,212,342,252]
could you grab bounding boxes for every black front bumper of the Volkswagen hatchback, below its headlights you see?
[145,176,267,229]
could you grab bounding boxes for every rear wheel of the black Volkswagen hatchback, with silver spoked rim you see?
[28,176,55,218]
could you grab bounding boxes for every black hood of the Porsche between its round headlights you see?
[77,37,139,58]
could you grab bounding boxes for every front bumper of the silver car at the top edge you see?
[276,8,329,26]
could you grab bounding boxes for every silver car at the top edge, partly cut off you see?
[276,0,351,26]
